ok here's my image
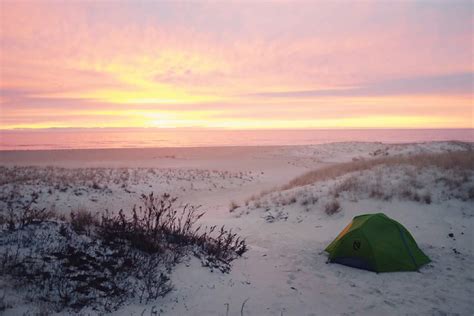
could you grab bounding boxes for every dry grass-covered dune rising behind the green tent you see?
[246,150,474,222]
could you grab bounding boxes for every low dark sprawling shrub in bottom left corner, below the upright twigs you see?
[0,221,171,314]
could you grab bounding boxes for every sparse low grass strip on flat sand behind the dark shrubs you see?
[0,166,259,215]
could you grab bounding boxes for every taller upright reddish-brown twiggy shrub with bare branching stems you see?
[99,193,247,272]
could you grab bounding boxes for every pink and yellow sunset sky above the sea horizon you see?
[0,0,474,129]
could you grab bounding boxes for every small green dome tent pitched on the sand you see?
[325,213,430,272]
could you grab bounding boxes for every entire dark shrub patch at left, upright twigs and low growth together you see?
[0,194,247,312]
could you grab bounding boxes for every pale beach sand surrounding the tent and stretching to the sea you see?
[0,142,474,315]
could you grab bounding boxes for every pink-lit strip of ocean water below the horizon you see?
[0,128,474,150]
